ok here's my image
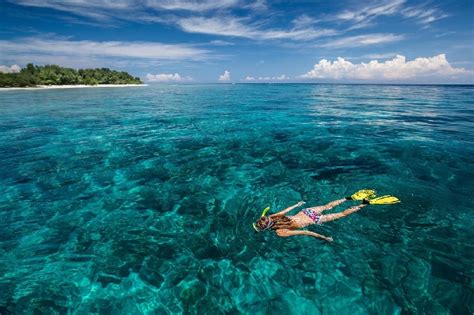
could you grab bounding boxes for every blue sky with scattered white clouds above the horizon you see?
[0,0,474,83]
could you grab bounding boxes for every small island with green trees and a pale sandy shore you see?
[0,63,143,88]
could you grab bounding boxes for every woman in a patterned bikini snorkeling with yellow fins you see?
[253,189,400,242]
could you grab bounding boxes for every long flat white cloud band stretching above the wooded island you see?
[0,37,208,61]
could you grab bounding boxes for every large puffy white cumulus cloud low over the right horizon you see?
[301,54,470,82]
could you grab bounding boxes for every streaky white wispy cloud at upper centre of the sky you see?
[176,16,338,40]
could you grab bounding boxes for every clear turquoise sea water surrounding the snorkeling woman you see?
[0,85,474,315]
